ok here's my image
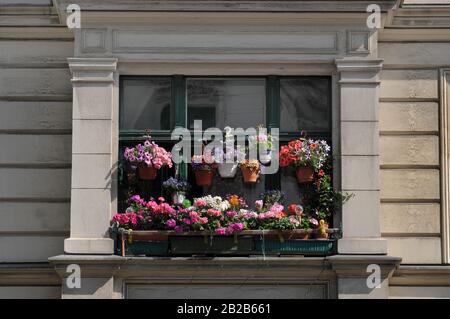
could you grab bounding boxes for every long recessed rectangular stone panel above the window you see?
[112,28,338,54]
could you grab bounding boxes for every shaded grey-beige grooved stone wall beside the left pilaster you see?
[0,5,73,264]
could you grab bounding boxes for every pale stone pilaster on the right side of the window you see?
[336,58,387,254]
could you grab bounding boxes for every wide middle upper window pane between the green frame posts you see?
[187,79,266,129]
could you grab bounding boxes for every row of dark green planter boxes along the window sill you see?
[117,229,337,256]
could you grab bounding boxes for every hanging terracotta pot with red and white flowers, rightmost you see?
[279,137,330,184]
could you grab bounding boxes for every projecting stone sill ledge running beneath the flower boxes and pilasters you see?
[49,255,401,278]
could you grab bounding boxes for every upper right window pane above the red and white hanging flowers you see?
[280,77,331,133]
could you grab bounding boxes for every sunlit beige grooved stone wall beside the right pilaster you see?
[378,42,442,264]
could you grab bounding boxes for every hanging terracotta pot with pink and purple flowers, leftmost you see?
[124,139,172,180]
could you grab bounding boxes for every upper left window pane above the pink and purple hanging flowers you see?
[121,78,171,130]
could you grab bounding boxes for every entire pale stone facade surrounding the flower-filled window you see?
[0,0,450,298]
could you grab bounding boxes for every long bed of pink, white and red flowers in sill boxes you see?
[110,192,335,256]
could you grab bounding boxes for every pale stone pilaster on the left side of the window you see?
[64,58,117,254]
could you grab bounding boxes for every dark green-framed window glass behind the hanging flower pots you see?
[119,75,331,209]
